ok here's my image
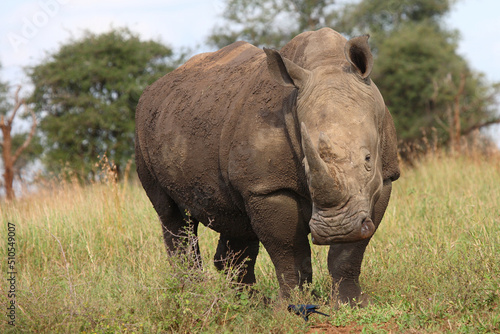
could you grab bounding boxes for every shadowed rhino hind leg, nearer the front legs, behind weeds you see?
[214,234,259,285]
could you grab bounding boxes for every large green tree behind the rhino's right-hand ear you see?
[339,0,500,147]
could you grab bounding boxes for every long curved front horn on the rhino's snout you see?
[301,123,344,208]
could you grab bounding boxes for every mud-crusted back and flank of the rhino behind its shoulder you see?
[136,42,265,231]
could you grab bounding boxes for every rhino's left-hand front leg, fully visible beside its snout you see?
[247,191,312,297]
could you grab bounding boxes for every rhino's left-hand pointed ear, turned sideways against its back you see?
[264,48,311,89]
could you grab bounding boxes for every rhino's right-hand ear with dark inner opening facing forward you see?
[344,35,373,79]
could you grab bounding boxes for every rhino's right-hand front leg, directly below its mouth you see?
[328,181,392,307]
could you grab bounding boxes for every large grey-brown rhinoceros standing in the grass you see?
[135,28,399,304]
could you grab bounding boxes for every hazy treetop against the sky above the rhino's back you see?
[207,0,338,48]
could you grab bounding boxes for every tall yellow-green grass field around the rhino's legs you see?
[0,156,500,333]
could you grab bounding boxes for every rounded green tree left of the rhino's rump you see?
[28,28,177,178]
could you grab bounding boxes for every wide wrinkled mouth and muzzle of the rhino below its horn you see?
[309,211,375,245]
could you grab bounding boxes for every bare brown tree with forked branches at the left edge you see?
[0,83,36,201]
